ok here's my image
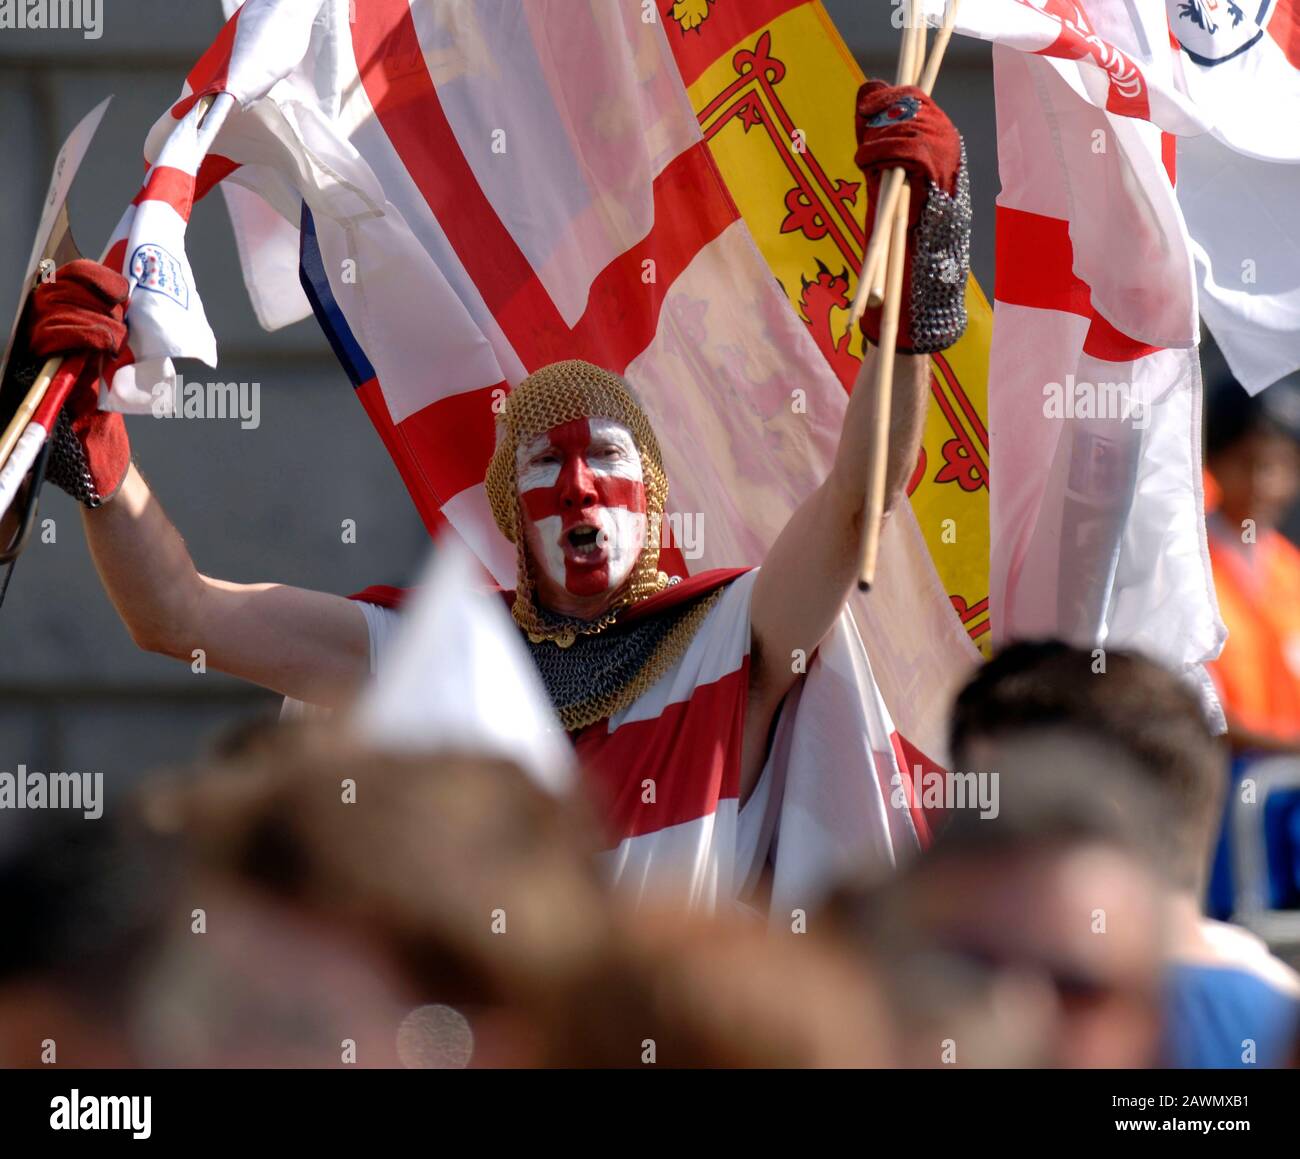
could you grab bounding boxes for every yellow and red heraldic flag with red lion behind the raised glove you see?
[663,0,993,648]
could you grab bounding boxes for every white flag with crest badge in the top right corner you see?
[946,0,1300,391]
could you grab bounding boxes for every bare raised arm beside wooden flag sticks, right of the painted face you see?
[750,348,930,707]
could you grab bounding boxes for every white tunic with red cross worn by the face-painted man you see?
[332,570,917,920]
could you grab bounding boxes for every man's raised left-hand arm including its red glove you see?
[15,261,369,706]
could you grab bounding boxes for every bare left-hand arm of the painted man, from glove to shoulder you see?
[83,465,369,706]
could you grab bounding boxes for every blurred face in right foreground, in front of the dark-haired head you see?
[831,734,1164,1067]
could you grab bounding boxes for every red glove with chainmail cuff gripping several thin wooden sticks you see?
[854,81,970,352]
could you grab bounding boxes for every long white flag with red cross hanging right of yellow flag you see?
[930,0,1225,709]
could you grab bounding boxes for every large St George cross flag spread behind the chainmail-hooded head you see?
[114,0,975,783]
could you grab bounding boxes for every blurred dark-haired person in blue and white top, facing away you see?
[953,643,1300,1067]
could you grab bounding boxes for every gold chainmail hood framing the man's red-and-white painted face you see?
[486,359,668,643]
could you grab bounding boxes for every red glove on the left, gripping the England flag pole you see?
[26,259,131,507]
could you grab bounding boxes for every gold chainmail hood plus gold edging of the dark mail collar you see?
[486,359,723,732]
